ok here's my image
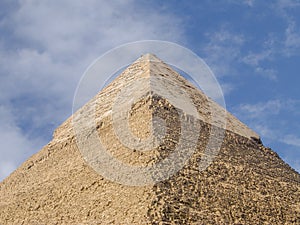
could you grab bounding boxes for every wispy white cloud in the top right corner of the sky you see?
[242,0,300,77]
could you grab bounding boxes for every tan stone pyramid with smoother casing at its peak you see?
[0,54,300,224]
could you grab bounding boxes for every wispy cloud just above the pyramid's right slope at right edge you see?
[234,99,300,171]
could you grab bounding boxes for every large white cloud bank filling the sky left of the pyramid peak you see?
[0,0,184,180]
